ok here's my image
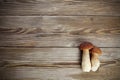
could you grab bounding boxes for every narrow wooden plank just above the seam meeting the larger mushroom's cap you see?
[0,34,120,48]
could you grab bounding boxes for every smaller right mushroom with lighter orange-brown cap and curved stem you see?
[91,47,102,71]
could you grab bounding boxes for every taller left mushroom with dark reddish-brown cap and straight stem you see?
[80,42,93,72]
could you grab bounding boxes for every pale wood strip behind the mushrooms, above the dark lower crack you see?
[0,48,120,64]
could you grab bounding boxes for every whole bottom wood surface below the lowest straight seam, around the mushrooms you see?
[0,48,120,80]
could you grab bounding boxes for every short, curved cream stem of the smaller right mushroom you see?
[91,53,100,71]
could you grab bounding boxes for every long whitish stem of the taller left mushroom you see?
[82,49,91,72]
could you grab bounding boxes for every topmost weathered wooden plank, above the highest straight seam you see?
[0,0,120,16]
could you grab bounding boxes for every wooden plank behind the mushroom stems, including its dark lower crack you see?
[0,48,120,67]
